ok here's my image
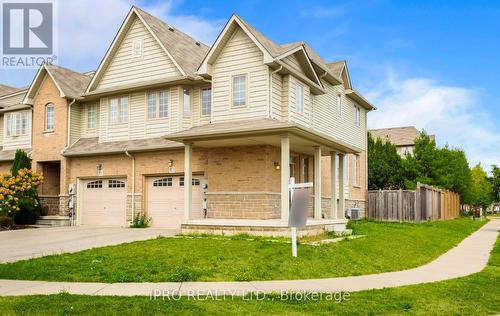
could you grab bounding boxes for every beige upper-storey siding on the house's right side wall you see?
[313,81,366,150]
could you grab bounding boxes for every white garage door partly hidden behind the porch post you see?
[147,176,204,228]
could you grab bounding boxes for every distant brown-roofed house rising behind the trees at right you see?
[370,126,435,157]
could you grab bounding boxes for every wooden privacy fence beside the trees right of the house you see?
[367,183,460,223]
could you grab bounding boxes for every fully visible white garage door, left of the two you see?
[80,179,127,226]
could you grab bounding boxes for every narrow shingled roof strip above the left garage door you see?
[62,137,183,157]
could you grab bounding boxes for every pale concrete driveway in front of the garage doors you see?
[0,226,179,263]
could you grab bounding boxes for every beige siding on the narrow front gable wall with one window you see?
[212,28,269,122]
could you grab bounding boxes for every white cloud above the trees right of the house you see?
[365,69,500,170]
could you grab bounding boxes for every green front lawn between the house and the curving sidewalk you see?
[0,218,485,282]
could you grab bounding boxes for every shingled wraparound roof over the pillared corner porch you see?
[165,118,361,153]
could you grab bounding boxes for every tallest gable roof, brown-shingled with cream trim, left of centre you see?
[85,6,210,93]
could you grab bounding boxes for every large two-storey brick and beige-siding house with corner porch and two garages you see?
[4,7,374,232]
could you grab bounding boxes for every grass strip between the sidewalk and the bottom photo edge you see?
[0,233,500,316]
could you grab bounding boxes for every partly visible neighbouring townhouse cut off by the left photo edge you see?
[0,85,32,174]
